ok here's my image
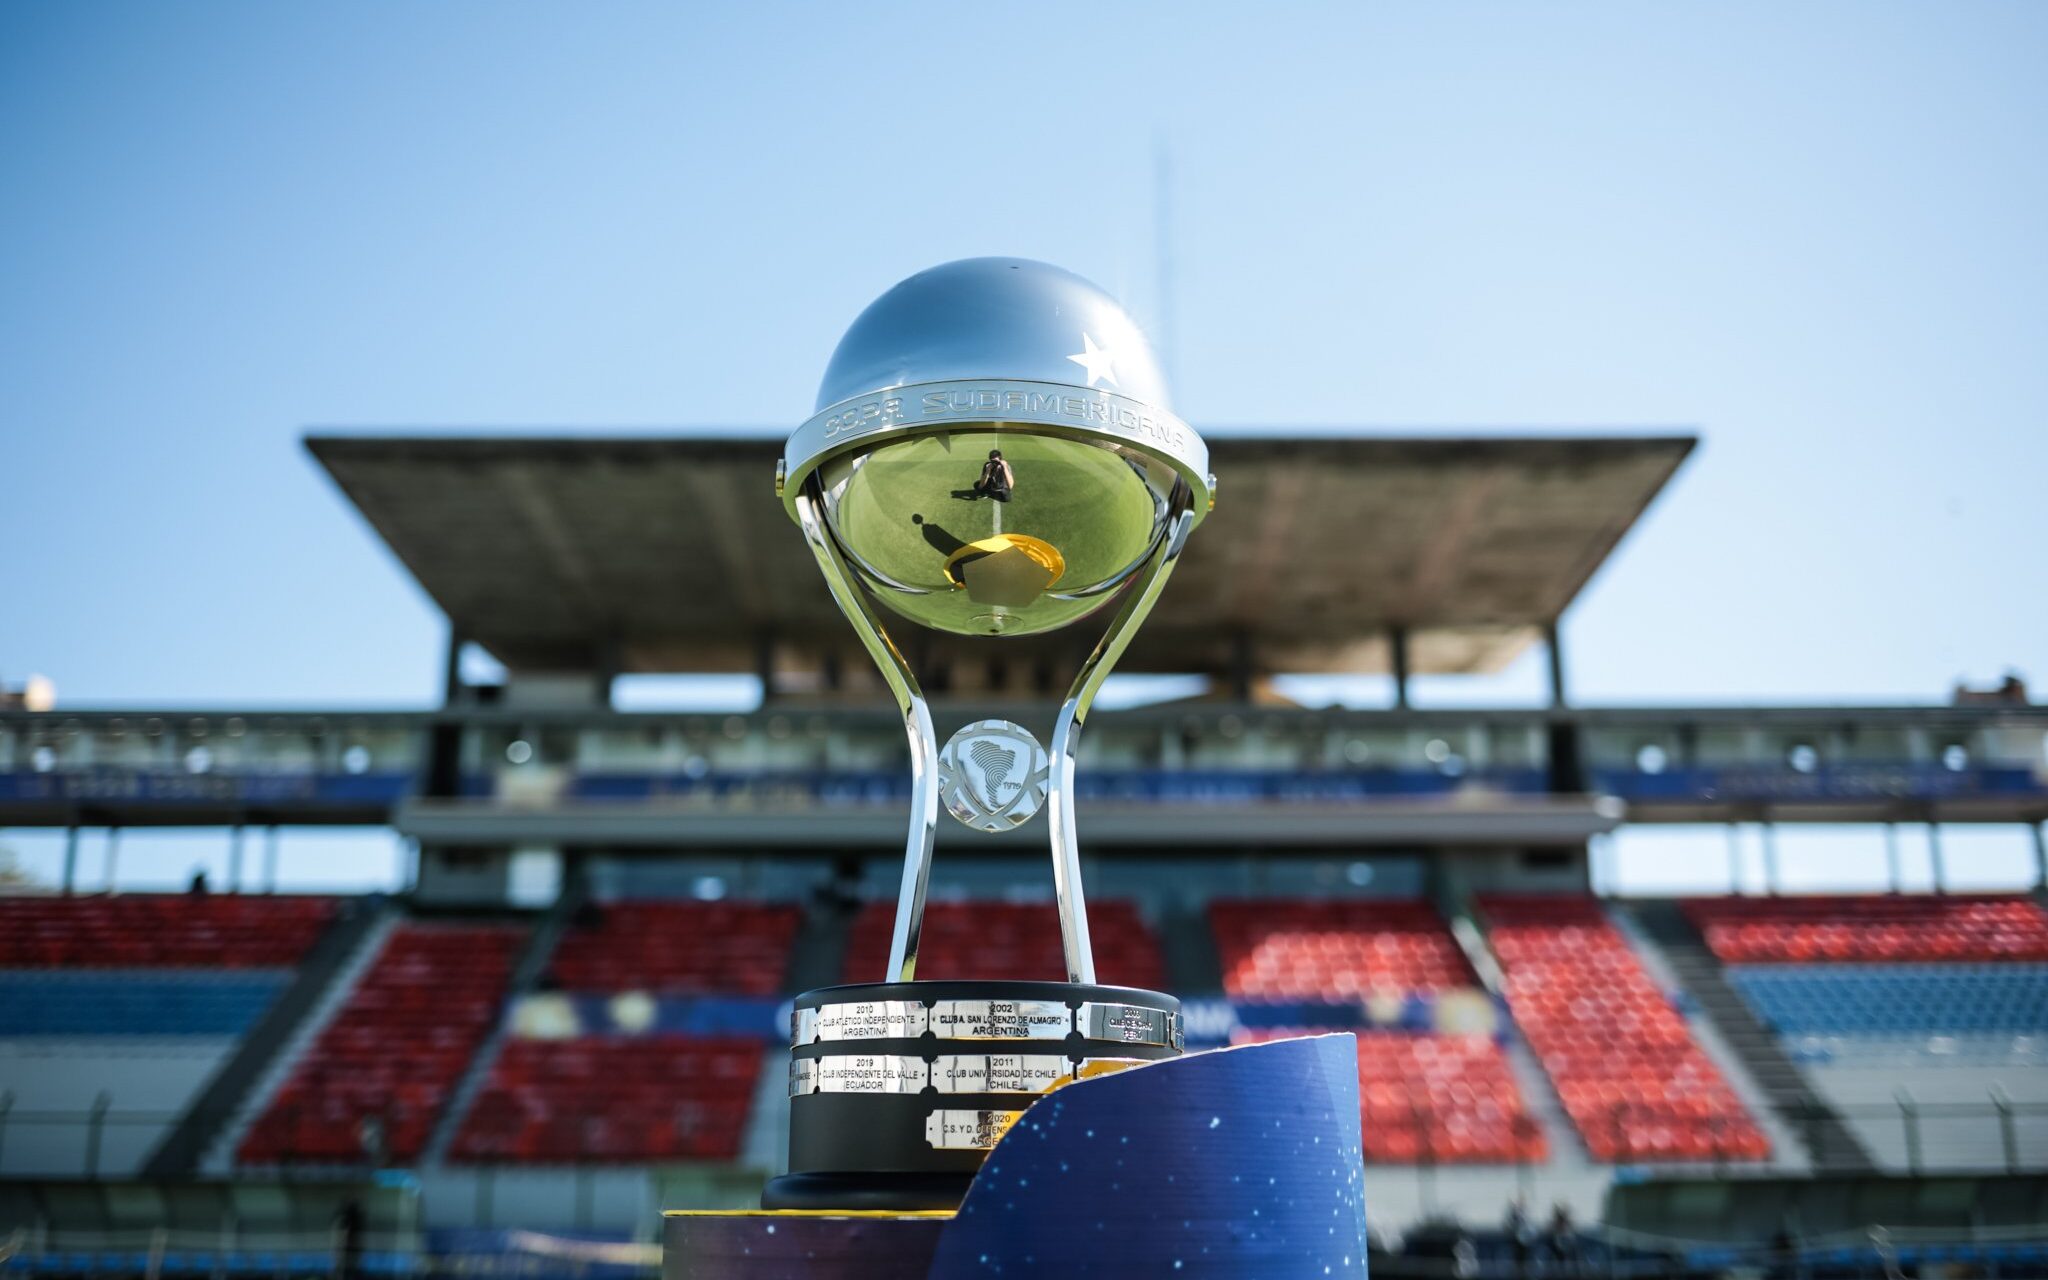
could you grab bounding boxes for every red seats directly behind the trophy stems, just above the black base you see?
[844,901,1165,991]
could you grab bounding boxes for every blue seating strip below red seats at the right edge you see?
[1729,965,2048,1036]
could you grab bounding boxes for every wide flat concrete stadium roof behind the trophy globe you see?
[305,432,1696,674]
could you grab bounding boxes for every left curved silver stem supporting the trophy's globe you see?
[797,477,937,983]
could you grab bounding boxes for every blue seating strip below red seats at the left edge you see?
[0,971,291,1036]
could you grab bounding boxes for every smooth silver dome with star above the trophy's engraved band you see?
[817,258,1171,412]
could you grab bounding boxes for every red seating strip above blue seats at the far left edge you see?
[0,893,336,969]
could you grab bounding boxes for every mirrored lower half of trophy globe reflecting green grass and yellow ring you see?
[819,424,1176,635]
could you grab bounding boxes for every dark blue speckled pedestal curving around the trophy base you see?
[664,1034,1366,1280]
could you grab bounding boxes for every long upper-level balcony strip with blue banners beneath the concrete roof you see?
[16,707,2048,821]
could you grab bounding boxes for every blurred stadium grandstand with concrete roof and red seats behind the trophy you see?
[0,432,2048,1276]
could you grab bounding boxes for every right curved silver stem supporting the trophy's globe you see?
[1047,508,1194,983]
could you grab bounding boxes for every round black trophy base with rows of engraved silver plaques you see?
[762,981,1182,1212]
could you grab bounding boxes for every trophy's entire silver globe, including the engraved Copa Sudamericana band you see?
[782,258,1210,637]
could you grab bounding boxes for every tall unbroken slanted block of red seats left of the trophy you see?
[238,924,526,1165]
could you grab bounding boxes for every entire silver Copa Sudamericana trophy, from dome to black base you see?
[762,258,1214,1210]
